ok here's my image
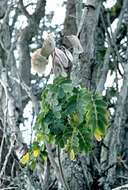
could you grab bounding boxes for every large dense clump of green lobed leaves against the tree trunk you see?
[34,77,108,159]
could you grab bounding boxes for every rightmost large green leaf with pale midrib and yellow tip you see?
[86,94,108,140]
